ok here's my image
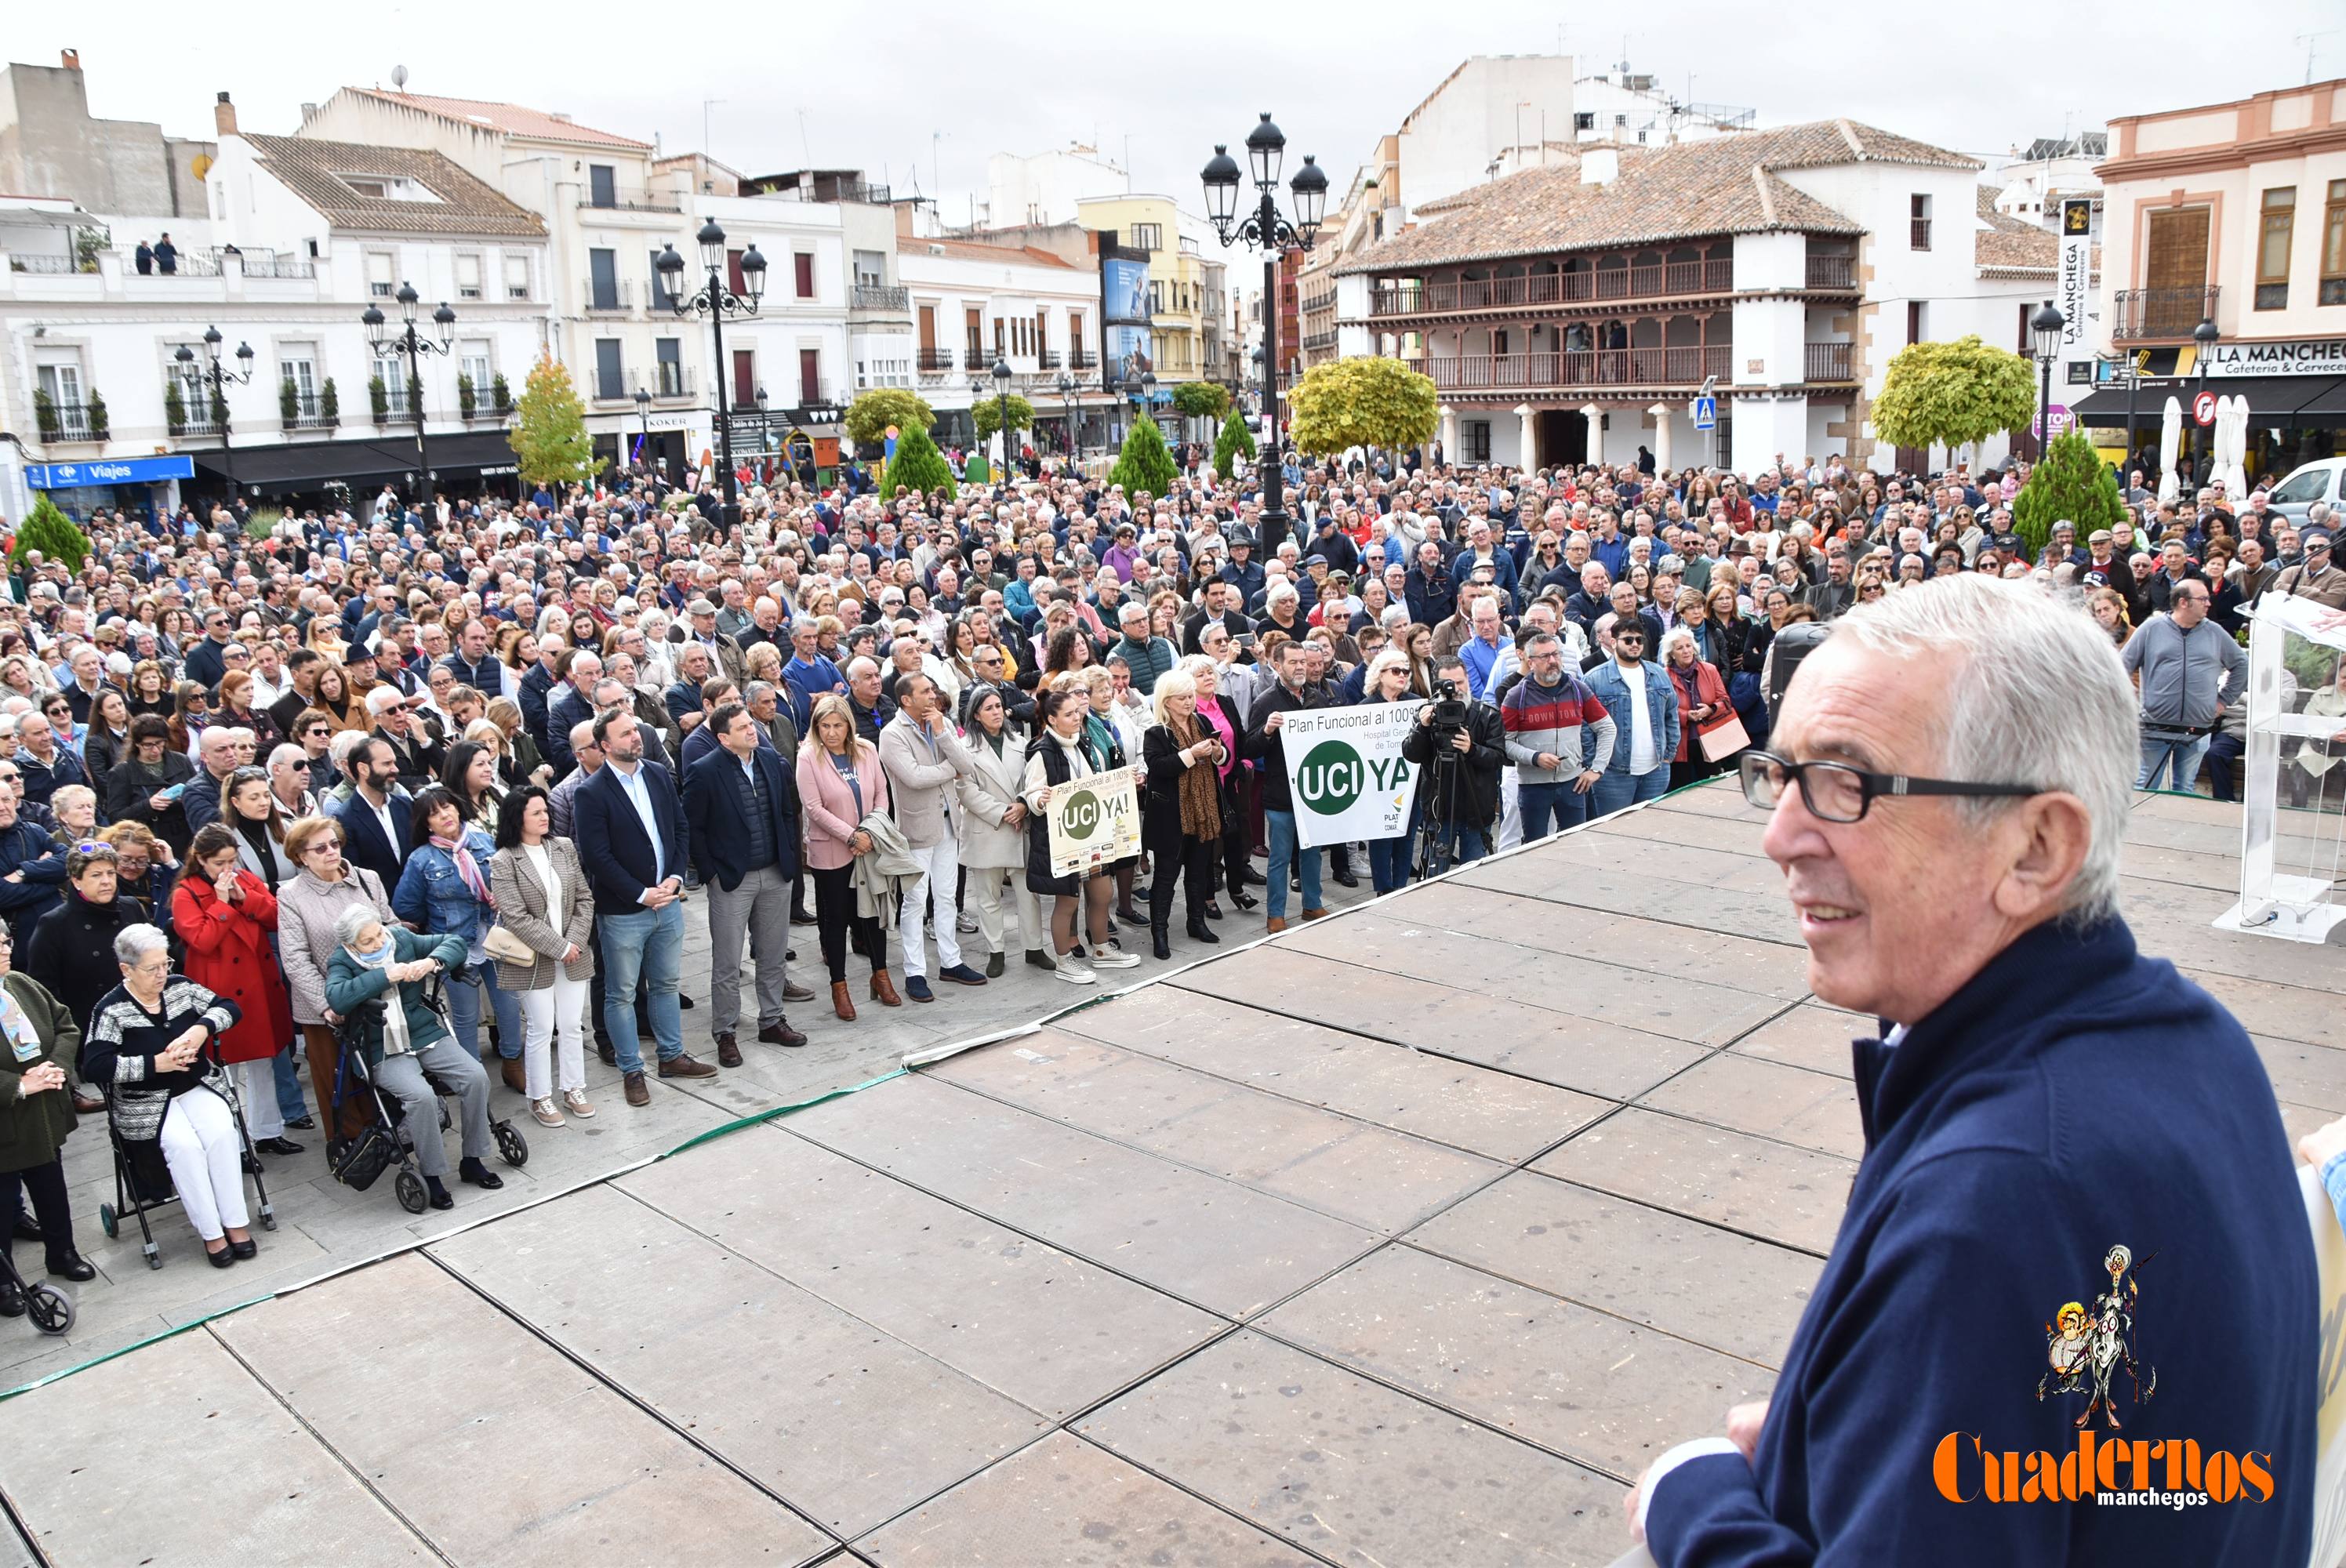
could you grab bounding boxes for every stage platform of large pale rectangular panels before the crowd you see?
[0,784,2346,1568]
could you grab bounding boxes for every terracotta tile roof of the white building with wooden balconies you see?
[1337,120,1980,272]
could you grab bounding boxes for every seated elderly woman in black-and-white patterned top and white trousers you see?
[82,925,258,1268]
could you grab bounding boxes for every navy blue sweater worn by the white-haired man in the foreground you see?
[1647,920,2320,1568]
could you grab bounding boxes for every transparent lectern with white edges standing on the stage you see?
[2217,591,2346,942]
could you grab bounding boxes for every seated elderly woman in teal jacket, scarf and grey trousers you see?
[326,904,504,1209]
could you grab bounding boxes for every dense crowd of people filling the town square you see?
[0,431,2346,1310]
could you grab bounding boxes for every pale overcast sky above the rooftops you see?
[7,0,2346,220]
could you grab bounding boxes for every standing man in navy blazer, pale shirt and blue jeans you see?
[570,709,716,1105]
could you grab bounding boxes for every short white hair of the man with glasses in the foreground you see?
[1835,573,2140,925]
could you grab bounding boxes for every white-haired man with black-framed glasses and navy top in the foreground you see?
[1625,573,2322,1568]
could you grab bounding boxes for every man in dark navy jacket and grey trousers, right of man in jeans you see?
[685,702,814,1068]
